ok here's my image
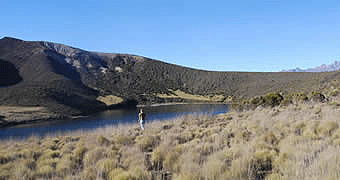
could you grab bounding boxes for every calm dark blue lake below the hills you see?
[0,104,228,139]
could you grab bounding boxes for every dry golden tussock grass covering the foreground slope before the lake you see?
[0,102,340,180]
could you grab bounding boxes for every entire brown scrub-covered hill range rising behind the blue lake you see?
[0,37,340,119]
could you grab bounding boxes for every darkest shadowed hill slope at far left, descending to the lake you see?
[0,38,105,116]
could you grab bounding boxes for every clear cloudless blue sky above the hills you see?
[0,0,340,72]
